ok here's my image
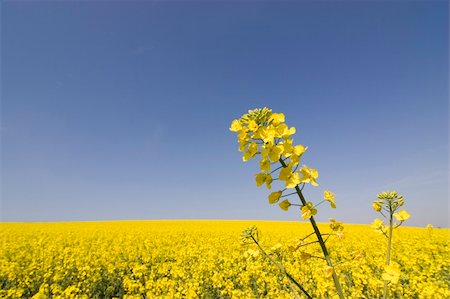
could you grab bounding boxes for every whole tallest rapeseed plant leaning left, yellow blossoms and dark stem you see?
[230,108,344,299]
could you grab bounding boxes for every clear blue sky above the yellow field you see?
[1,1,449,226]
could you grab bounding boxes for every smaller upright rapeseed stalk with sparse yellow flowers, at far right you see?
[372,191,410,298]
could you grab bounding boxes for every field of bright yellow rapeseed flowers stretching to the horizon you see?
[0,220,450,298]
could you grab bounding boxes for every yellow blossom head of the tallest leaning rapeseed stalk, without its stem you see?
[230,108,328,213]
